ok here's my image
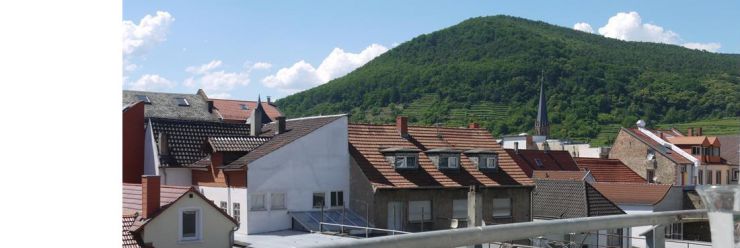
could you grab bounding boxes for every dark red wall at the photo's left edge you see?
[121,102,145,183]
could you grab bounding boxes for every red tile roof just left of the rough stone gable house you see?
[575,158,647,183]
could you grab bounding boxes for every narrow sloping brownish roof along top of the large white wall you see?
[222,115,345,169]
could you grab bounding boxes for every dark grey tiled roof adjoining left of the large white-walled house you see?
[149,118,249,167]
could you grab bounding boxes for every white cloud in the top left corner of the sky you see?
[123,11,175,55]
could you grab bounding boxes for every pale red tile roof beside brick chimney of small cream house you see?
[123,183,190,212]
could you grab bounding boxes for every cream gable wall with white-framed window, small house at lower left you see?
[142,193,236,248]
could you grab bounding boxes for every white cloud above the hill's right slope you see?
[592,11,721,52]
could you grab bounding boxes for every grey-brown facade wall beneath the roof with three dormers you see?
[372,186,534,232]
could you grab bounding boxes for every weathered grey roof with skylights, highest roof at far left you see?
[123,90,220,121]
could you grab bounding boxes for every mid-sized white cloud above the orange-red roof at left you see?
[183,60,251,92]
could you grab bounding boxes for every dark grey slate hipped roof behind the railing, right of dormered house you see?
[532,179,624,219]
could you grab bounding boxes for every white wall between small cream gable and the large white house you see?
[198,186,249,238]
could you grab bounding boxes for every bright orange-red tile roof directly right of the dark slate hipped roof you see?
[592,183,671,205]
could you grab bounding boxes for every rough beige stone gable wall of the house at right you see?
[609,130,688,185]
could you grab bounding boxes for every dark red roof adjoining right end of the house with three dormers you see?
[506,149,579,177]
